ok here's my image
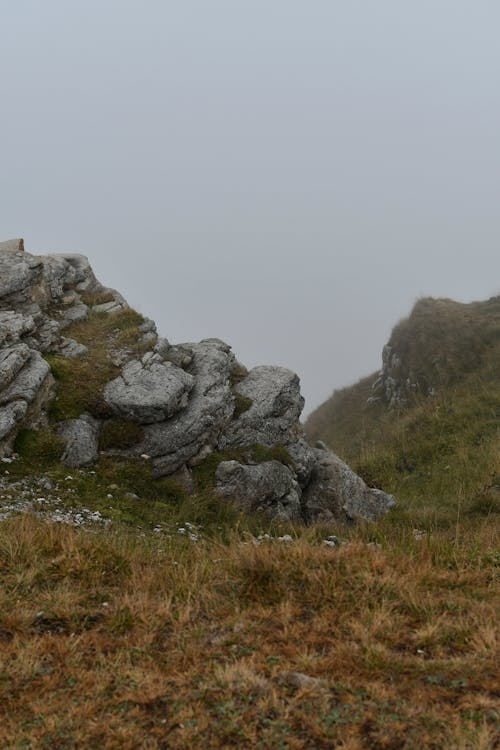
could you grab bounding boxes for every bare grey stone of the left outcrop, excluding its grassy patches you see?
[0,240,394,521]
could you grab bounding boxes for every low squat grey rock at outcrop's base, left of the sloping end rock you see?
[215,461,301,521]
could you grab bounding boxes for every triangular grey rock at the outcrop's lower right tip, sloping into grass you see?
[303,449,396,521]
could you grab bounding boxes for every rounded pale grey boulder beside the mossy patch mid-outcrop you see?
[104,360,194,424]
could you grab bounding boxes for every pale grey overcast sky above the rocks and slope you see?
[0,0,500,412]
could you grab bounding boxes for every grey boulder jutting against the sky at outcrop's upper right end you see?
[220,366,304,449]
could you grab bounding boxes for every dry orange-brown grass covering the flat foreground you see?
[0,517,499,750]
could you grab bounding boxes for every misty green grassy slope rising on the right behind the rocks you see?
[306,298,500,525]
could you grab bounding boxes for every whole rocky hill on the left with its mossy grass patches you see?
[0,240,394,523]
